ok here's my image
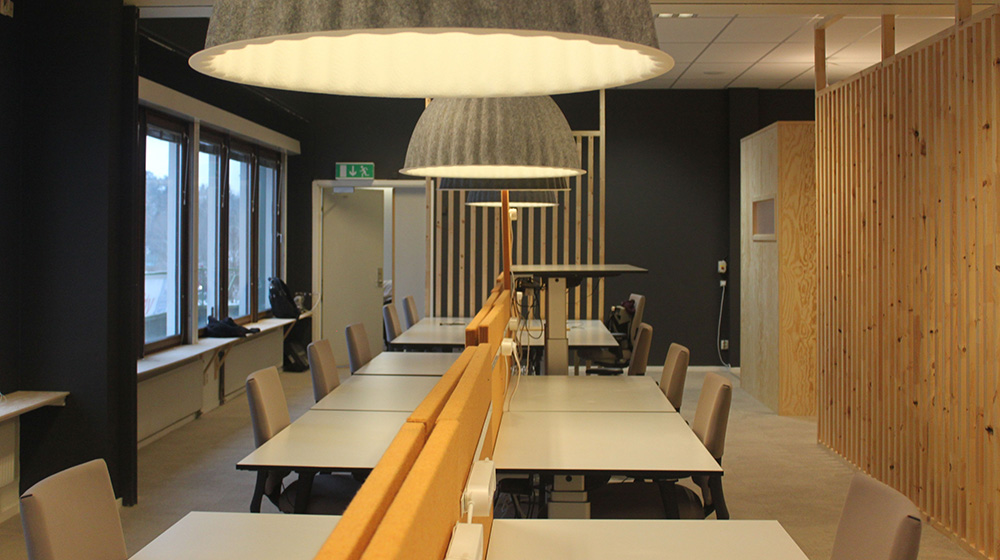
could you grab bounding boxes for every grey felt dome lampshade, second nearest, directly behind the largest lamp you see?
[400,97,585,179]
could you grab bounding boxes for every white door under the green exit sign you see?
[322,189,384,366]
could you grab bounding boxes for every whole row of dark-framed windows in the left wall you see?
[142,110,281,352]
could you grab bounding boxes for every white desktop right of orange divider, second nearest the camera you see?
[493,411,722,477]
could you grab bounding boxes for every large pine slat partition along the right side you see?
[816,9,1000,559]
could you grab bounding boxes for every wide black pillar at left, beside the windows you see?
[13,0,136,504]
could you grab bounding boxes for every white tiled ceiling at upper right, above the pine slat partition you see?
[628,13,955,89]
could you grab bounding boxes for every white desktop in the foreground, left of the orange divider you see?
[132,511,340,560]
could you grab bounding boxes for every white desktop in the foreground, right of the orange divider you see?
[486,519,807,560]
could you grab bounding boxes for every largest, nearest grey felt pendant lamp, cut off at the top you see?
[189,0,674,97]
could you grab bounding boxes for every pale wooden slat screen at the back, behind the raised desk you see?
[431,131,606,319]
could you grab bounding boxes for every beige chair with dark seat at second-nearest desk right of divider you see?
[590,373,733,519]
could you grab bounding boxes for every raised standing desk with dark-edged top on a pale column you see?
[510,264,648,375]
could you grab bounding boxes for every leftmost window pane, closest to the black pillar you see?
[143,119,186,344]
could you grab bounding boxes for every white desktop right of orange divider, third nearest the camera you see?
[508,375,675,413]
